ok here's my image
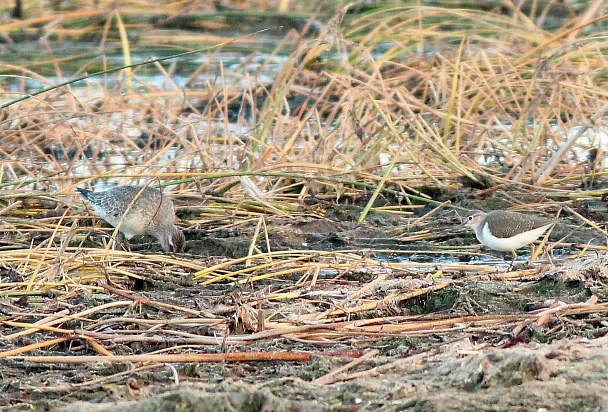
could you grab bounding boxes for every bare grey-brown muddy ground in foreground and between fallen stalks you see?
[0,198,608,411]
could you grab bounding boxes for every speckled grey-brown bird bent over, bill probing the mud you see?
[76,185,186,253]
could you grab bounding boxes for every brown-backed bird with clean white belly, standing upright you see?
[463,210,557,265]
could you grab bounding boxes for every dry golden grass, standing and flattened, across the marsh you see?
[0,0,608,406]
